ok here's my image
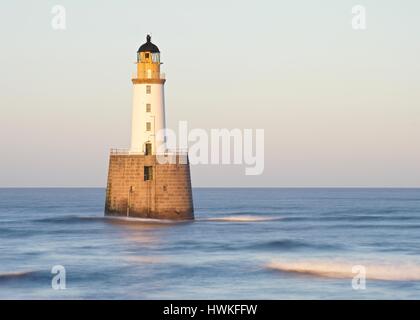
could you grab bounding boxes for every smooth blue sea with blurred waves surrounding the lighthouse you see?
[0,188,420,300]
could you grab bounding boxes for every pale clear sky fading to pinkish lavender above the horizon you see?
[0,0,420,187]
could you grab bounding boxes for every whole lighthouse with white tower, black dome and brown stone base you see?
[105,35,194,220]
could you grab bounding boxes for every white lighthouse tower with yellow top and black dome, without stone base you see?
[130,35,165,155]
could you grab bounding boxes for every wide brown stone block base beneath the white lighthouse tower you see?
[105,153,194,220]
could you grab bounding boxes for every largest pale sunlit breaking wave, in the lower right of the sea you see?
[266,261,420,281]
